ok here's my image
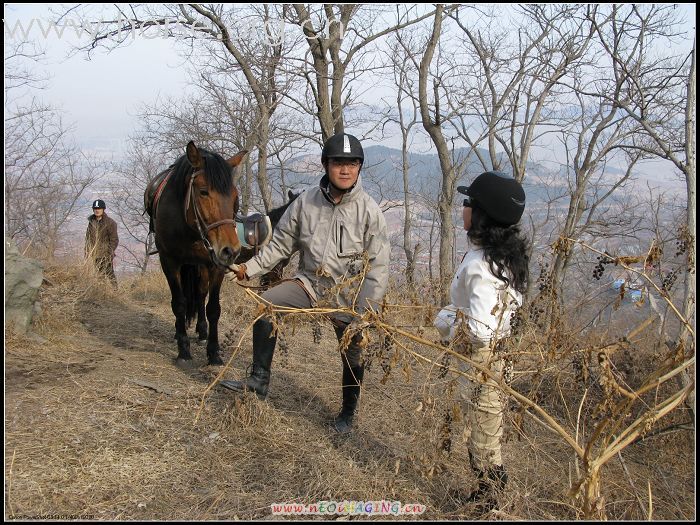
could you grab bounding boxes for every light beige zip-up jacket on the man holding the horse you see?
[246,176,390,321]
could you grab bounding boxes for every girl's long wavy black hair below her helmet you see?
[467,206,530,294]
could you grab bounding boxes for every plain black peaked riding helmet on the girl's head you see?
[457,171,525,226]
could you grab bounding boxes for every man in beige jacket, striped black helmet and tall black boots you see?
[221,133,390,433]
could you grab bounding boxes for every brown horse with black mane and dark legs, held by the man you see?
[144,141,247,366]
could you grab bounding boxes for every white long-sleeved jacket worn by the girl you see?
[433,248,523,343]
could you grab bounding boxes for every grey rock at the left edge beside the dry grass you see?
[5,236,44,333]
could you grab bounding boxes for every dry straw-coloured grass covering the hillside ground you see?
[5,266,695,520]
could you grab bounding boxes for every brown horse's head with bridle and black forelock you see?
[185,141,247,266]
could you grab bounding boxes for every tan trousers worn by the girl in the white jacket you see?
[458,344,505,470]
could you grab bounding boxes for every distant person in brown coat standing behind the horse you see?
[85,199,119,288]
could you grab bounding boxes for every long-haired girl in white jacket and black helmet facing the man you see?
[435,171,529,512]
